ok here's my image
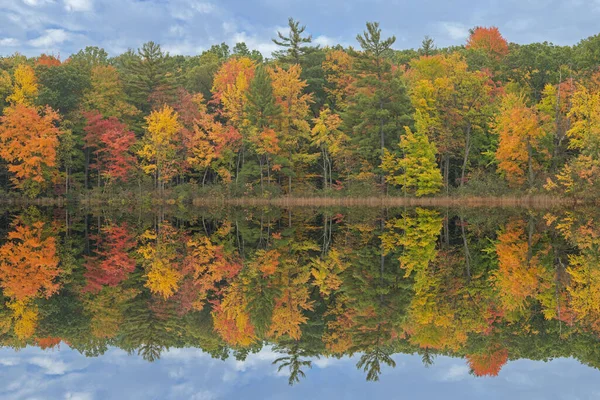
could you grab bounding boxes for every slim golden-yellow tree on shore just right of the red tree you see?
[138,105,181,192]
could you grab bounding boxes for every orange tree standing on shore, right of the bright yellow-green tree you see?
[493,93,550,187]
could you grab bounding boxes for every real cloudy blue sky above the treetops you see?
[0,0,600,58]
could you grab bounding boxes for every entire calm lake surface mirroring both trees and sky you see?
[0,207,600,399]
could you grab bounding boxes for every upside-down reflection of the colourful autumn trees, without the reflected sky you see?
[0,208,600,384]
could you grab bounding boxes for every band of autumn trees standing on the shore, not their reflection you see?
[0,19,600,200]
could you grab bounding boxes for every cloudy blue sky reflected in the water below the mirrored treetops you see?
[0,345,600,400]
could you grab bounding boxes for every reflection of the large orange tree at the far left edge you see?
[0,222,60,301]
